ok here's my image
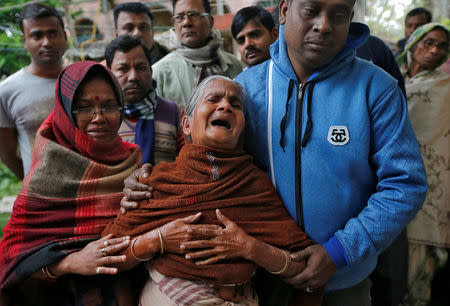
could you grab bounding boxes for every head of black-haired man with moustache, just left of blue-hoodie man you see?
[231,6,278,67]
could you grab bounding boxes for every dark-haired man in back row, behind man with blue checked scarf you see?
[114,2,169,65]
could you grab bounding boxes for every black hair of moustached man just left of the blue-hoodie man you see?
[231,6,275,39]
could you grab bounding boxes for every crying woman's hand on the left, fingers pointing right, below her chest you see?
[160,213,222,254]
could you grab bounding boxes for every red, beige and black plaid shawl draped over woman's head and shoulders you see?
[0,62,140,300]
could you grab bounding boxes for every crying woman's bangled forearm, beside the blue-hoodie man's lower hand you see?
[246,238,305,277]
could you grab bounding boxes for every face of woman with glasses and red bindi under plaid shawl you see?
[72,78,120,142]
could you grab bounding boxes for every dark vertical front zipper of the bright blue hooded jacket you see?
[295,83,307,231]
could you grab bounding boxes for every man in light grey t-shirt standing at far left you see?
[0,3,67,179]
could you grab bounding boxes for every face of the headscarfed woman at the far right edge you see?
[412,28,448,70]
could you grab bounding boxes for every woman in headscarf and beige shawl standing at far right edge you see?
[399,23,450,305]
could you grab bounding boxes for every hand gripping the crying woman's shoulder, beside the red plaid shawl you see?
[120,164,153,214]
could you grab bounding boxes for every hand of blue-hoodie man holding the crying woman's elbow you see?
[284,244,337,290]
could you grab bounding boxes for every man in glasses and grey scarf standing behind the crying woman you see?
[153,0,242,107]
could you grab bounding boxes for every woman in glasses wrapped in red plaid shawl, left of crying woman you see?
[0,61,141,305]
